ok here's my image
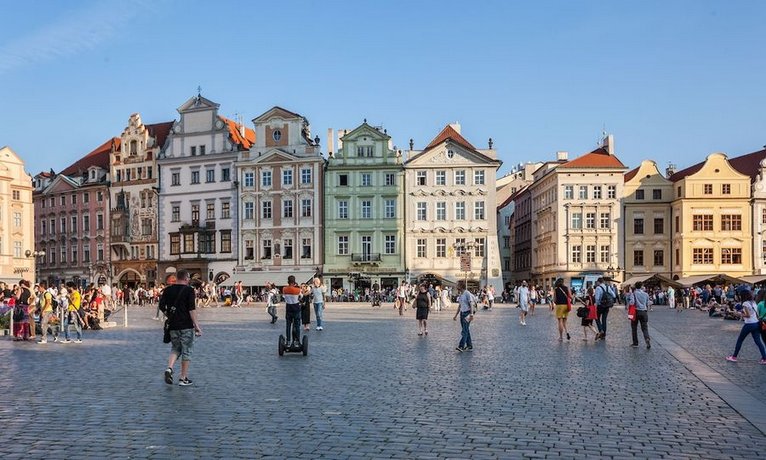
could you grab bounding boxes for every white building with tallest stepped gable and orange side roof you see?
[157,94,255,282]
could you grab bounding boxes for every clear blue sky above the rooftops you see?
[0,0,766,174]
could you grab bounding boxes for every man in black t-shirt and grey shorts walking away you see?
[159,270,202,386]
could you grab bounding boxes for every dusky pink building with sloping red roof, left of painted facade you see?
[33,137,120,285]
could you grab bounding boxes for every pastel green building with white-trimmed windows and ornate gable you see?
[324,120,405,292]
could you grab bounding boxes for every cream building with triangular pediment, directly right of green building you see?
[405,124,503,293]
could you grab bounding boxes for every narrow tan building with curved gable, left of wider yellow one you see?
[622,160,673,280]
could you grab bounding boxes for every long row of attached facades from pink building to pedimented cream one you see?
[15,94,507,289]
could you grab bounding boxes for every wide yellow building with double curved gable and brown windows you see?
[670,153,753,278]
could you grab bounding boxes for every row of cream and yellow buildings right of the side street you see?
[508,136,766,287]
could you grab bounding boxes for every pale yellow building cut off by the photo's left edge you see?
[0,147,35,284]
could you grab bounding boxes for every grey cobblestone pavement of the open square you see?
[0,304,766,459]
